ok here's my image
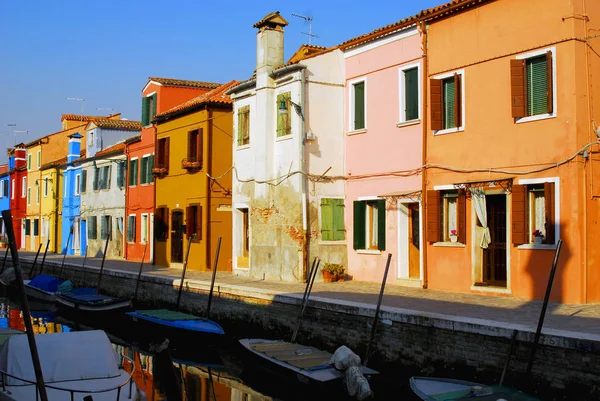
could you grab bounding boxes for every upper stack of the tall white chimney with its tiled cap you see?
[254,11,288,76]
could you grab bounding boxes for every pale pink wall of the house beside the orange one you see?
[344,29,423,282]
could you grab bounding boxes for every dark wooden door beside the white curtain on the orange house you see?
[483,195,507,287]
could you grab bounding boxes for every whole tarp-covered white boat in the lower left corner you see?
[0,330,145,401]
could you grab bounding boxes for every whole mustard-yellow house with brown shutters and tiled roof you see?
[152,81,238,271]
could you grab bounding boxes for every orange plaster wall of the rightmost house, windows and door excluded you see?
[427,0,600,303]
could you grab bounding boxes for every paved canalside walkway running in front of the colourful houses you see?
[8,252,600,341]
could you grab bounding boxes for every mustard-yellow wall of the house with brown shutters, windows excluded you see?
[155,106,233,271]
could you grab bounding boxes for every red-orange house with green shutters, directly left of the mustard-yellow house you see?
[125,77,221,262]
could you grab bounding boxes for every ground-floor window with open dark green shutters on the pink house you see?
[354,199,385,251]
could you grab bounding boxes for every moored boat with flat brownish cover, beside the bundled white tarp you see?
[240,338,378,384]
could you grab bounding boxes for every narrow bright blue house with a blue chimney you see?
[61,133,86,255]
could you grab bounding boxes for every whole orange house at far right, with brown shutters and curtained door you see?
[424,0,600,303]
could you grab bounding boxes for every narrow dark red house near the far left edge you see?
[8,143,29,249]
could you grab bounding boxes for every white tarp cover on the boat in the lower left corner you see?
[0,330,121,385]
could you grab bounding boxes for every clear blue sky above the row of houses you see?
[0,0,444,164]
